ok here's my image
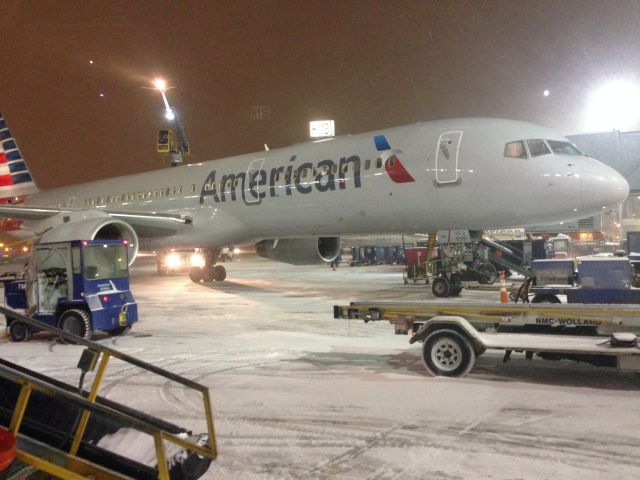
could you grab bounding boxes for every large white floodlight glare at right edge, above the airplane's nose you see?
[585,80,640,131]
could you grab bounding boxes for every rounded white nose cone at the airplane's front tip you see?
[580,159,629,214]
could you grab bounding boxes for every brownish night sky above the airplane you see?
[0,0,640,188]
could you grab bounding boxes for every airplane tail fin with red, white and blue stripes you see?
[0,113,38,203]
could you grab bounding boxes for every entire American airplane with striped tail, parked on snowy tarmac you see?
[0,113,629,282]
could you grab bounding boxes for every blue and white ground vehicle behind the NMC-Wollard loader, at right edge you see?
[519,257,640,304]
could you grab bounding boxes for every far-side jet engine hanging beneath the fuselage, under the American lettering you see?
[256,237,340,265]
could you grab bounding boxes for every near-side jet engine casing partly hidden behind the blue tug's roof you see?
[40,216,138,265]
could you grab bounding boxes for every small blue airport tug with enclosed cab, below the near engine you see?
[4,240,138,341]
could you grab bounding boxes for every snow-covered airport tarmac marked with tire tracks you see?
[0,253,640,480]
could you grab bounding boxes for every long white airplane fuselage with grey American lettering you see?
[26,119,628,248]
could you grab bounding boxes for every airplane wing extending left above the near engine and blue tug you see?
[0,205,192,237]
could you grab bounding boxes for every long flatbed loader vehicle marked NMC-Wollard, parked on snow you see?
[334,302,640,377]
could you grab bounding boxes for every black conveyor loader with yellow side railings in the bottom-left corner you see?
[0,307,217,480]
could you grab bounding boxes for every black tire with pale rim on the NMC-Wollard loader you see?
[422,329,476,377]
